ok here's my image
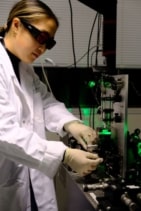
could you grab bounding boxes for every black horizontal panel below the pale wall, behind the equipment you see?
[35,67,141,108]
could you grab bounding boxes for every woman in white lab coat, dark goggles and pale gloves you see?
[0,0,101,211]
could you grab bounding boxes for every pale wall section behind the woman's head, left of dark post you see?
[0,0,104,67]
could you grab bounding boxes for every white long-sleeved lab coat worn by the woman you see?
[0,42,77,211]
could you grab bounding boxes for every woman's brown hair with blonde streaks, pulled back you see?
[0,0,59,36]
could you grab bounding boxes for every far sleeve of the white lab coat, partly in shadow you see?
[36,74,82,137]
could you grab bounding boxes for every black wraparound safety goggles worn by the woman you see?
[20,18,56,50]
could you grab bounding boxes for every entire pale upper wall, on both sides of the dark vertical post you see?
[0,0,141,68]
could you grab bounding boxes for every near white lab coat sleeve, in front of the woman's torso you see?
[0,65,67,178]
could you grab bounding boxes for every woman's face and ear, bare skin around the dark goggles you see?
[4,18,57,63]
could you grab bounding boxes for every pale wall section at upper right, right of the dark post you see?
[116,0,141,68]
